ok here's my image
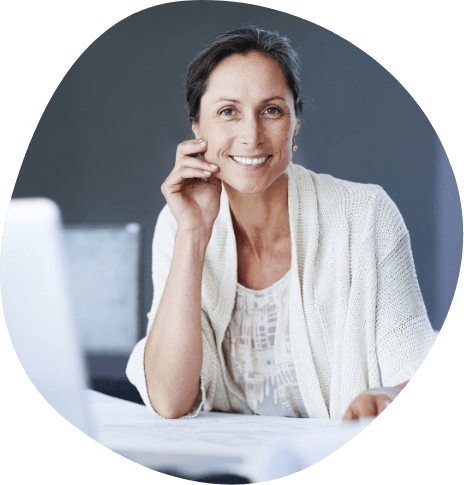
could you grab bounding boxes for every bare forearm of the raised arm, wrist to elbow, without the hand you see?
[145,230,211,418]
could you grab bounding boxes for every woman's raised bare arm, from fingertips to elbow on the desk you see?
[144,140,221,418]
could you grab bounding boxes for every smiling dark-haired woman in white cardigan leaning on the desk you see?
[127,28,434,419]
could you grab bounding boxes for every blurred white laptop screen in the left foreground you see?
[0,198,92,436]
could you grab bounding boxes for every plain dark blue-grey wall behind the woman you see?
[13,1,463,336]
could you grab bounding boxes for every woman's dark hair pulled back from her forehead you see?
[186,26,303,123]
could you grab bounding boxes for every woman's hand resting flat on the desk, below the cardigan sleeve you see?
[343,381,409,420]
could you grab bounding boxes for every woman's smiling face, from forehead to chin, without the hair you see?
[192,52,299,194]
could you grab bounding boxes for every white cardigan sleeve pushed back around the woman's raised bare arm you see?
[126,205,214,417]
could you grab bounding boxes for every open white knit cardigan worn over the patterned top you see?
[126,164,435,418]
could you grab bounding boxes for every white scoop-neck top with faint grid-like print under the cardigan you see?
[222,271,308,417]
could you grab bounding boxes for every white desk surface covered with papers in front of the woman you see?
[87,390,372,482]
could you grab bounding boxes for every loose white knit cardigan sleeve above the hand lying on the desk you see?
[375,188,435,386]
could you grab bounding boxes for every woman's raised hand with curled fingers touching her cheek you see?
[161,140,222,234]
